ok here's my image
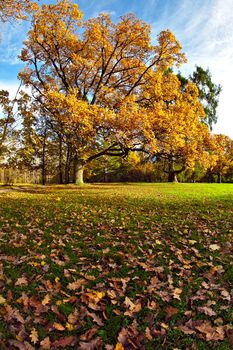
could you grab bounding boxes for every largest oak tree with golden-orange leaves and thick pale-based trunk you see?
[20,0,185,183]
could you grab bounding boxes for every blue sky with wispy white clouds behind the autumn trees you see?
[0,0,233,138]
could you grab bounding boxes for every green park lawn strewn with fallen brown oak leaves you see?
[0,184,233,350]
